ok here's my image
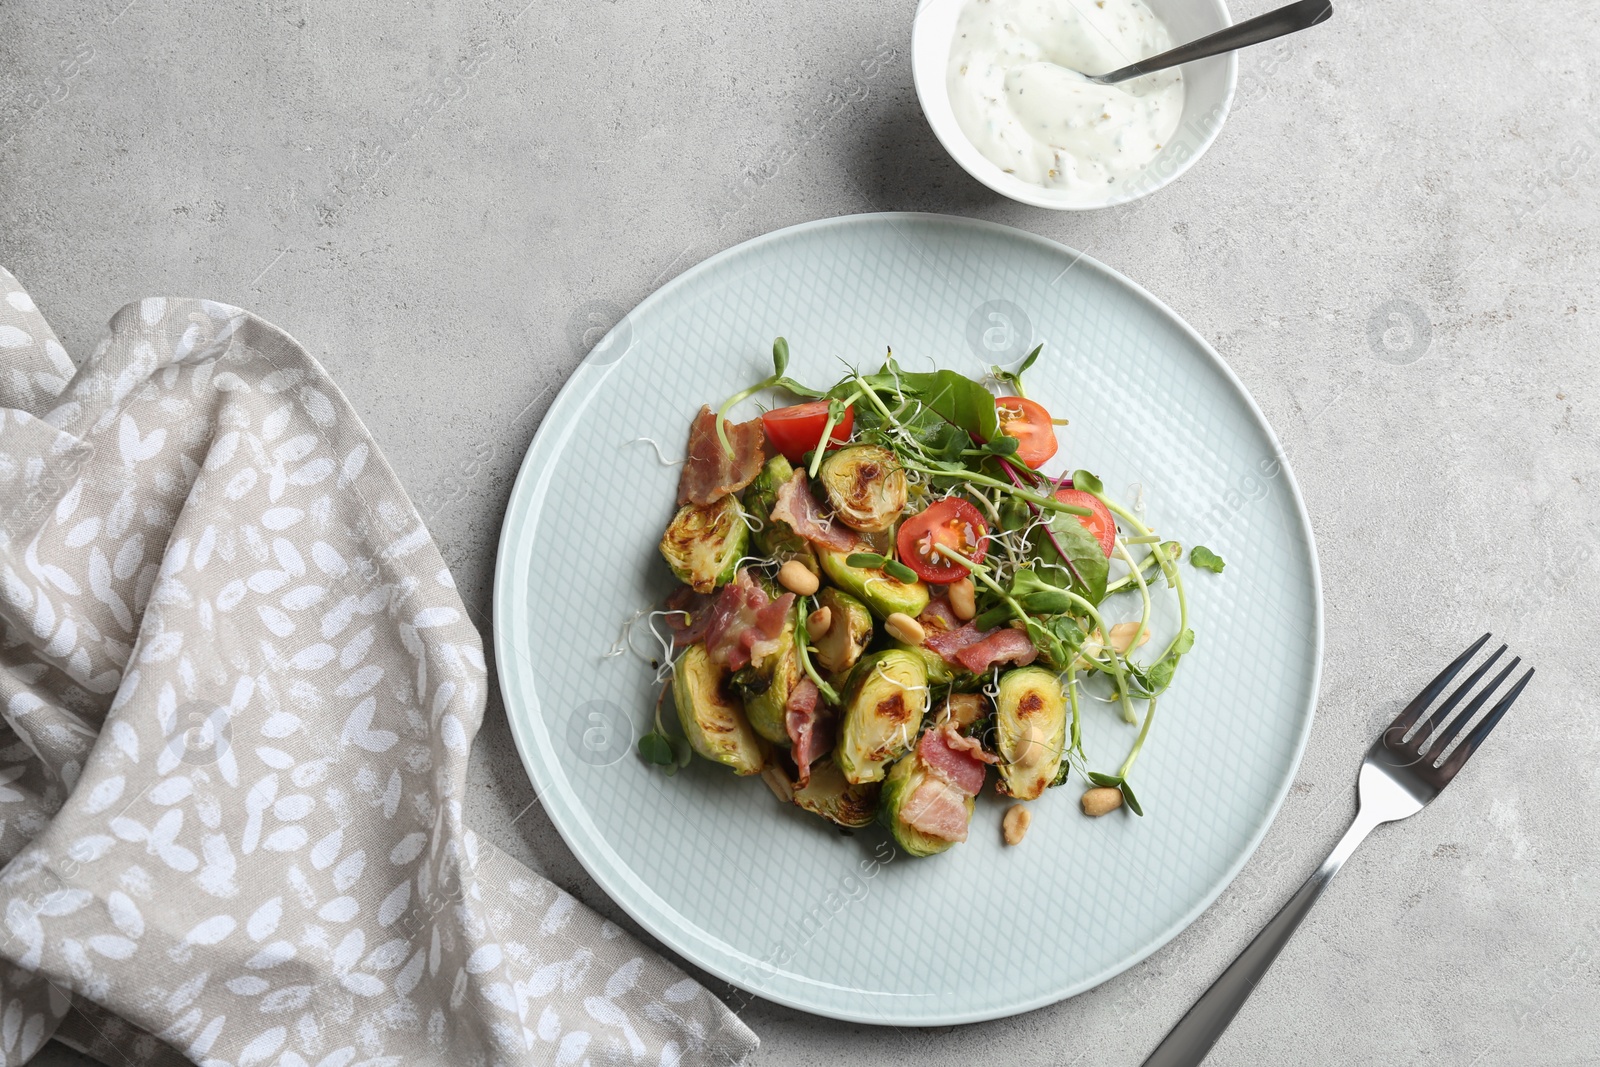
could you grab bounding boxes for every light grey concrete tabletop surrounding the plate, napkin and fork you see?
[0,0,1600,1067]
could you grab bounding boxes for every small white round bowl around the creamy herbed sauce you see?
[910,0,1238,211]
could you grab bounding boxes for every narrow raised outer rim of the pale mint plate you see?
[490,211,1325,1027]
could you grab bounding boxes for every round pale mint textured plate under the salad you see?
[494,214,1322,1025]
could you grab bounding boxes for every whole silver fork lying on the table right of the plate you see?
[1144,633,1533,1067]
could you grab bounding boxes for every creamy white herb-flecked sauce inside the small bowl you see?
[947,0,1184,203]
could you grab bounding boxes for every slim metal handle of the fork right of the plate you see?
[1144,811,1382,1067]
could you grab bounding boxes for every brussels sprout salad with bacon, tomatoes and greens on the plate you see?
[624,338,1224,856]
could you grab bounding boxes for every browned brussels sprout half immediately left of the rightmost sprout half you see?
[834,648,928,784]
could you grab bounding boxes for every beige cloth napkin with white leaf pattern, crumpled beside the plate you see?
[0,270,757,1067]
